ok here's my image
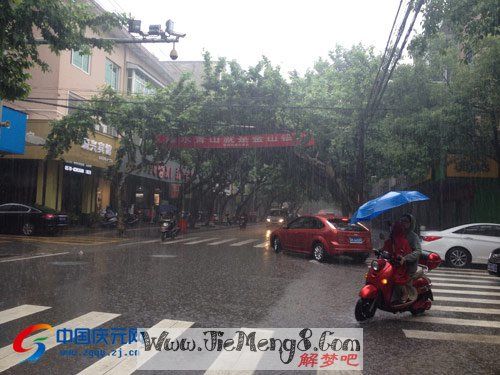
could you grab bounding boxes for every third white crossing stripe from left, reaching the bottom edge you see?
[78,319,194,375]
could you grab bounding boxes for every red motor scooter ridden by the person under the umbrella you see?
[354,250,441,322]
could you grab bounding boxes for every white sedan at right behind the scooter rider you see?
[420,223,500,268]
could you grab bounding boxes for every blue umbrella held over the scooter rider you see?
[351,191,429,223]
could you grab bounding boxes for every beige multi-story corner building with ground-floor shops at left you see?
[0,3,176,222]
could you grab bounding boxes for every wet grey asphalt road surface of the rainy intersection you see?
[0,226,500,374]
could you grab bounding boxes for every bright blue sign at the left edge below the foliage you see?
[0,106,28,154]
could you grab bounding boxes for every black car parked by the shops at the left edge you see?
[0,203,68,236]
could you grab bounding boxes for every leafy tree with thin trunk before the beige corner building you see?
[45,79,200,232]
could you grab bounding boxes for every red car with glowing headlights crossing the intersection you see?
[270,215,372,262]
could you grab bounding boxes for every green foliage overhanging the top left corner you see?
[0,0,125,100]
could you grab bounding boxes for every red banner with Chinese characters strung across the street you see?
[156,133,314,148]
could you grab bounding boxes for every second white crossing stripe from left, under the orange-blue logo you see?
[0,311,120,372]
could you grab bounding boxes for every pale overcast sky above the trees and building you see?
[98,0,406,73]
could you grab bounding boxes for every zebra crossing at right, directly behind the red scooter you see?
[403,268,500,345]
